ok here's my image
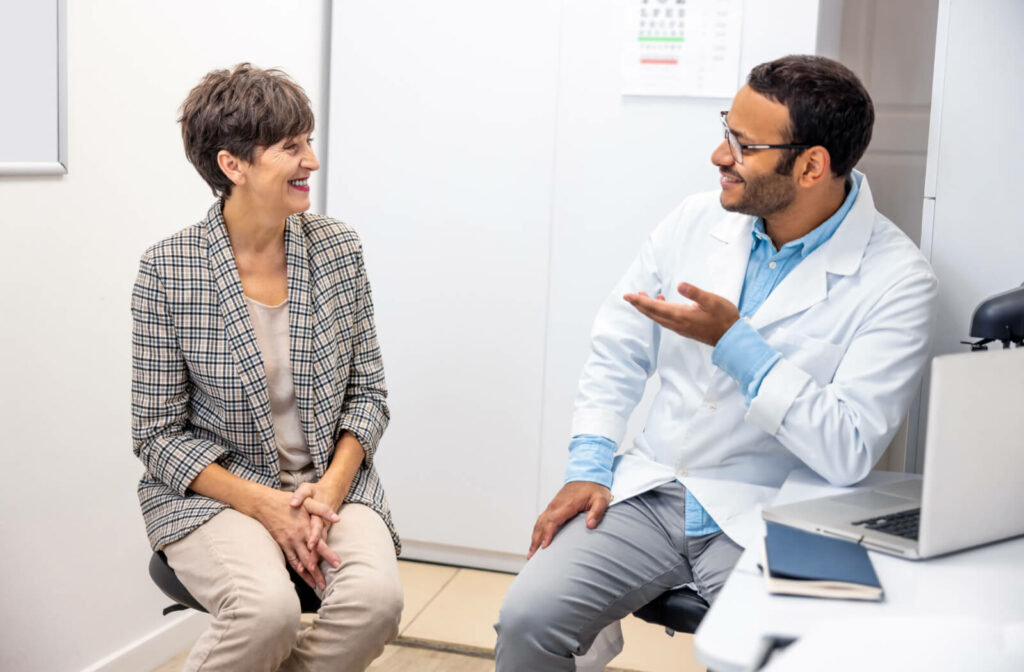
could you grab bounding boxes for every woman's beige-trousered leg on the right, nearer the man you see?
[281,503,403,672]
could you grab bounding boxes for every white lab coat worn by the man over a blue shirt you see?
[572,174,937,546]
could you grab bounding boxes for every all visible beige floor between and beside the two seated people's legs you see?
[154,560,703,672]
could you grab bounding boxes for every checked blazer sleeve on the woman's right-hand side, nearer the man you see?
[334,241,390,467]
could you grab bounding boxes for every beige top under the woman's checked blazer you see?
[246,296,312,471]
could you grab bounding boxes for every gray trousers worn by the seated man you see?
[495,482,742,672]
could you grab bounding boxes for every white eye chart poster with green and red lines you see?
[623,0,743,98]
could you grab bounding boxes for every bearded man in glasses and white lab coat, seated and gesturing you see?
[496,56,936,672]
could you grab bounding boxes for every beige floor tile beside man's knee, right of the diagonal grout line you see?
[402,570,515,650]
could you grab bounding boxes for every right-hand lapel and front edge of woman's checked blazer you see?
[285,217,317,473]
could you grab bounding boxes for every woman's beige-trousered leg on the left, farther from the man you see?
[164,509,299,672]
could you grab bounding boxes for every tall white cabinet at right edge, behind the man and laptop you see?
[916,0,1024,470]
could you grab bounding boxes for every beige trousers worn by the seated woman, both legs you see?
[164,470,402,672]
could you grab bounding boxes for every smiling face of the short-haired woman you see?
[228,133,319,219]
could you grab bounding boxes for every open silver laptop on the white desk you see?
[764,347,1024,559]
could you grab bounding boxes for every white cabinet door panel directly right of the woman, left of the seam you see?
[328,0,559,555]
